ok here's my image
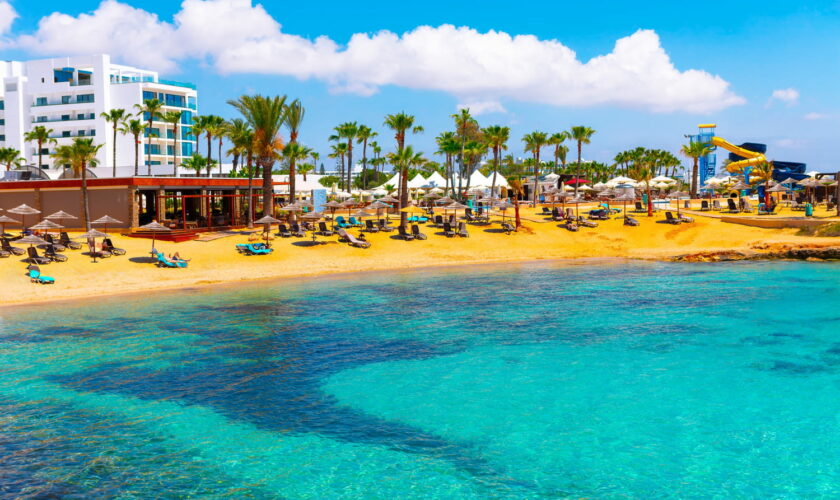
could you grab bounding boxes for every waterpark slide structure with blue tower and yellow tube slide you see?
[689,123,807,185]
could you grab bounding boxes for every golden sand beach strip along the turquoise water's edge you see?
[0,207,836,305]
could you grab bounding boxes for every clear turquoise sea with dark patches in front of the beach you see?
[0,261,840,499]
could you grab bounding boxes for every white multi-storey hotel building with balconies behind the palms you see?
[0,55,198,178]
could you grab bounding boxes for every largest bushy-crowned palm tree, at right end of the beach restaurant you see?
[228,95,287,215]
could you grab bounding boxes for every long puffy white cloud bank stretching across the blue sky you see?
[9,0,745,113]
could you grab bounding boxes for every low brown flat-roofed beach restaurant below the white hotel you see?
[0,177,286,231]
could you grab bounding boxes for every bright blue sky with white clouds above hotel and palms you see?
[0,0,840,171]
